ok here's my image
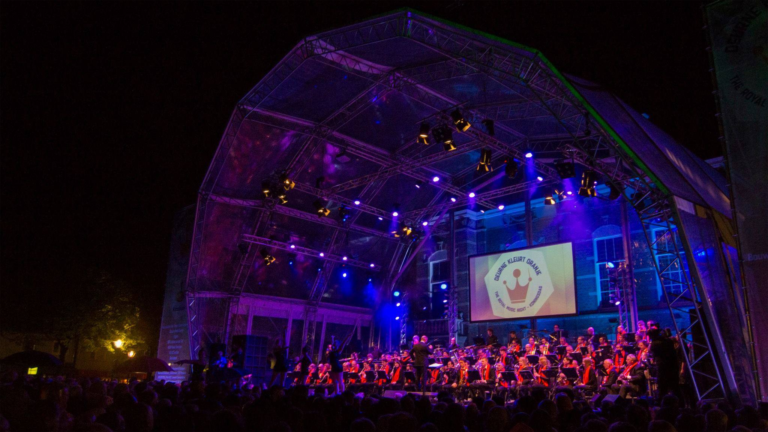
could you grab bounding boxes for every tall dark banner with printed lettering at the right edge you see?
[706,0,768,397]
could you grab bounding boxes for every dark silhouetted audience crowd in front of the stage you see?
[0,374,768,432]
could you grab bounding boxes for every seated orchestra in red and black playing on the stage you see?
[294,323,664,400]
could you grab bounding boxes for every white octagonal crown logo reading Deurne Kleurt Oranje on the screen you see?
[485,251,555,318]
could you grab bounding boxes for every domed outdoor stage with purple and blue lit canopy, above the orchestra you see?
[159,10,757,402]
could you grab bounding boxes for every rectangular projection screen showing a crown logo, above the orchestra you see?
[469,243,577,322]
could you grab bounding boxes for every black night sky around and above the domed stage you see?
[0,1,720,348]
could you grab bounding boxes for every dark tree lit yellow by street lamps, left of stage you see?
[45,270,143,366]
